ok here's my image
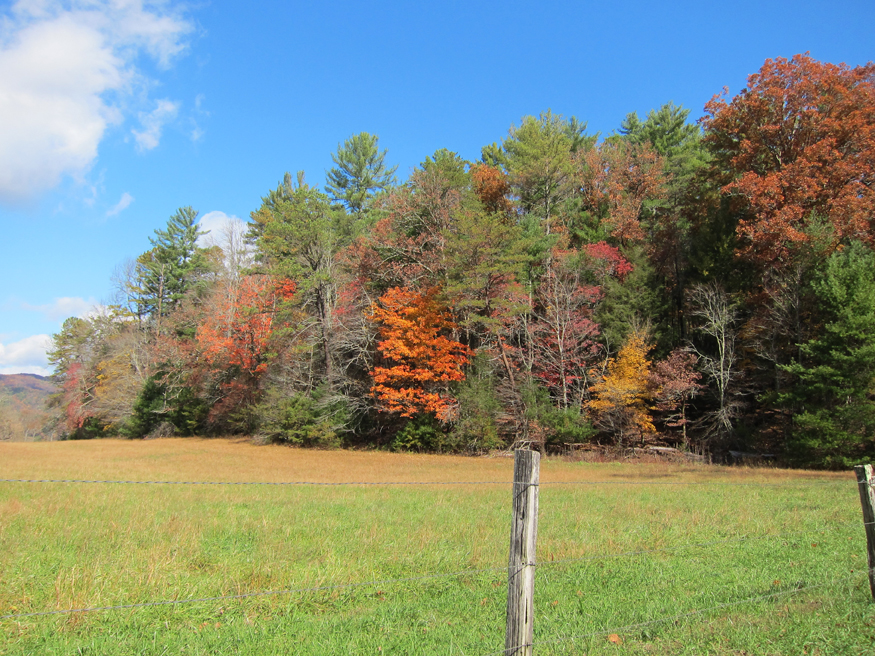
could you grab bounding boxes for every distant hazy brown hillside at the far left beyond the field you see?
[0,374,57,441]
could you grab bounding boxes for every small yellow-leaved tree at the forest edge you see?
[586,332,656,446]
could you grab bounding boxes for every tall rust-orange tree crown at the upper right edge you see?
[702,54,875,264]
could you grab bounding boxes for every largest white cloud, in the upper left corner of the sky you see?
[0,0,192,202]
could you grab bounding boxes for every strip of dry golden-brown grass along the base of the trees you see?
[0,438,852,486]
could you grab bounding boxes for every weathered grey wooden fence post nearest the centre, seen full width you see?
[504,449,541,656]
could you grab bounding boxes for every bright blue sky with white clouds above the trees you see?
[0,0,875,374]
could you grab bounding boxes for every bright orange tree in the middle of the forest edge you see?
[370,287,470,420]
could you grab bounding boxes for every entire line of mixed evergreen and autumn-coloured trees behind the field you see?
[49,55,875,467]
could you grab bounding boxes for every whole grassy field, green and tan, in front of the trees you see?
[0,439,875,656]
